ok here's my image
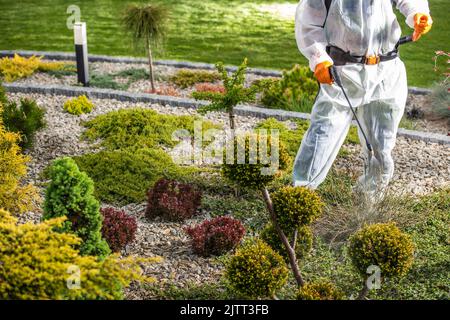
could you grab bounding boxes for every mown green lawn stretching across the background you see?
[0,0,450,87]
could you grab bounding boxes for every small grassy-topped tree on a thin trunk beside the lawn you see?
[122,4,168,92]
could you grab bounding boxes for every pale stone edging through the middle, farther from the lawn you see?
[3,83,450,145]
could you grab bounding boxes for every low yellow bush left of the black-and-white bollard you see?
[0,54,66,82]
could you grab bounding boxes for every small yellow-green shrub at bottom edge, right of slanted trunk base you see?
[297,280,345,300]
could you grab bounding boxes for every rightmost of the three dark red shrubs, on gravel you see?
[185,217,245,257]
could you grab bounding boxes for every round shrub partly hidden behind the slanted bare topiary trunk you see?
[260,223,313,261]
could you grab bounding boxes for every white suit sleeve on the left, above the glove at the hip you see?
[295,0,333,72]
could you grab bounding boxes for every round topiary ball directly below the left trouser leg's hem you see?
[272,186,324,230]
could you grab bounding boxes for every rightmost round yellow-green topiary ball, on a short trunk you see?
[349,223,414,277]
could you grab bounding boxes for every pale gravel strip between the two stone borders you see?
[13,58,450,135]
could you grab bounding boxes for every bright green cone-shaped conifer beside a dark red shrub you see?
[43,158,110,258]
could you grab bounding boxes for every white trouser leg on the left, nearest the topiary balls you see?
[293,95,352,189]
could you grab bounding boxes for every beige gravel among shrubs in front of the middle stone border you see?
[8,94,450,299]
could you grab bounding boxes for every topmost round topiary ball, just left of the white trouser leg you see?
[222,134,291,189]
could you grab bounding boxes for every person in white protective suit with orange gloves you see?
[293,0,432,195]
